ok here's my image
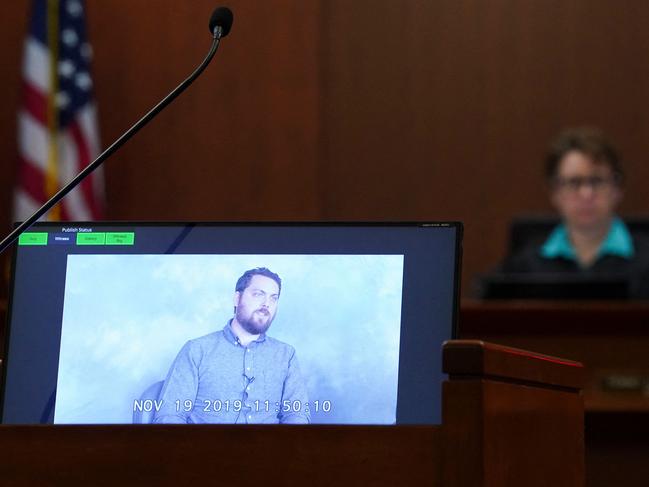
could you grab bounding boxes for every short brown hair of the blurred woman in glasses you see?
[545,127,624,183]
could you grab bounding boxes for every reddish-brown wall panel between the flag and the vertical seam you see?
[89,0,319,220]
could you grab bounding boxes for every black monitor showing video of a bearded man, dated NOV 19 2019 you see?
[2,223,462,424]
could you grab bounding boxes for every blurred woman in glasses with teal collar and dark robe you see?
[501,128,649,297]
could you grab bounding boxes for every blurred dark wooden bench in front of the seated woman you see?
[459,301,649,487]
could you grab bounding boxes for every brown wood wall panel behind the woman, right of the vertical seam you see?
[323,0,649,294]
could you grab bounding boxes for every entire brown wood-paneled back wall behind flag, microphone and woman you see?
[0,0,649,295]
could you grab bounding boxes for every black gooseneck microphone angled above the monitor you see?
[0,7,233,253]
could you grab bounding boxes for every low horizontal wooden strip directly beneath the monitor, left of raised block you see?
[0,425,443,487]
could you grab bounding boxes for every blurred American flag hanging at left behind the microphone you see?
[14,0,104,221]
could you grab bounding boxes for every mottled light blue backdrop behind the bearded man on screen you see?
[54,255,403,424]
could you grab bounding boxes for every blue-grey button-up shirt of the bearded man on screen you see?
[154,323,310,424]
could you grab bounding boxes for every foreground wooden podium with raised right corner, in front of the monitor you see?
[0,340,584,487]
